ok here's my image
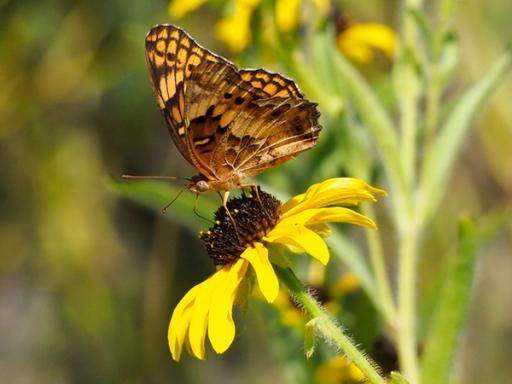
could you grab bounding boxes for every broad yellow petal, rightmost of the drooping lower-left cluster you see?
[208,259,248,353]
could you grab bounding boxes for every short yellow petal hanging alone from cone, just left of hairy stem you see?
[240,243,279,303]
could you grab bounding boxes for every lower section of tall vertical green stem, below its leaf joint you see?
[397,225,420,384]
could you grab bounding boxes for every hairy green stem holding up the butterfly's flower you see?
[274,266,386,384]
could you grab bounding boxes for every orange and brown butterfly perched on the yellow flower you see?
[146,24,321,198]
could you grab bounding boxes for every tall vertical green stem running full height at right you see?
[397,0,422,384]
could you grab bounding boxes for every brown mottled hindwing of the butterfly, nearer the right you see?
[186,61,320,178]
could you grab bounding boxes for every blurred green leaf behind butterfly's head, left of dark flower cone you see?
[108,180,217,230]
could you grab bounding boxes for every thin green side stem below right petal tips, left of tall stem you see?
[361,204,396,328]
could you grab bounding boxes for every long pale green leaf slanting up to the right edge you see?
[418,50,512,221]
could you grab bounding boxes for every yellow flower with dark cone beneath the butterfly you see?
[168,178,385,361]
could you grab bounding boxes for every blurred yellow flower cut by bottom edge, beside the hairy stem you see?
[314,356,366,384]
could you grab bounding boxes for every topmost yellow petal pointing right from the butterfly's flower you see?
[283,177,386,217]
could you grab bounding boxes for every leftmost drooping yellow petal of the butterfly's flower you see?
[167,283,203,361]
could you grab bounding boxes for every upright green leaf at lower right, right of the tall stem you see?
[421,218,477,384]
